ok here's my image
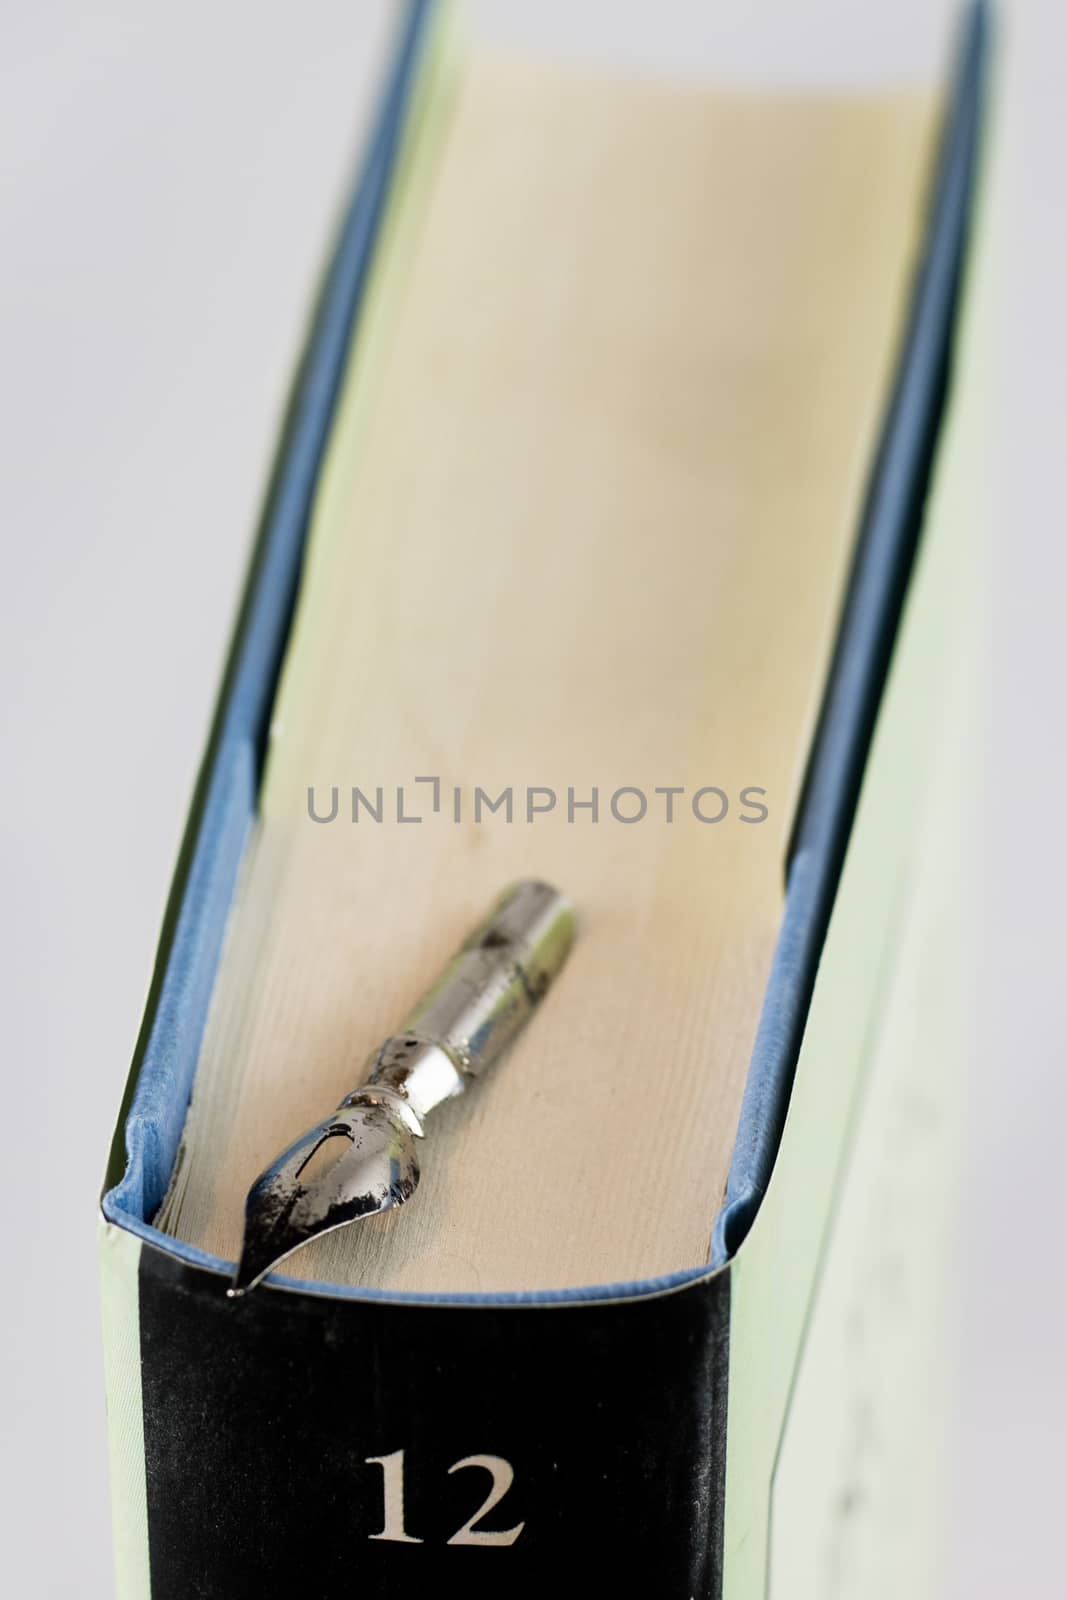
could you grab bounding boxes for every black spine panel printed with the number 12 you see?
[127,1245,729,1600]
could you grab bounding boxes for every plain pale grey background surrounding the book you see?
[0,0,1067,1600]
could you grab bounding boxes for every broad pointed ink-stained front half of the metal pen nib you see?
[227,1086,422,1298]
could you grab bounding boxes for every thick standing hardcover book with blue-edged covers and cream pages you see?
[101,5,987,1600]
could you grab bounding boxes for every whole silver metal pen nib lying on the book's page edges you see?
[229,882,574,1296]
